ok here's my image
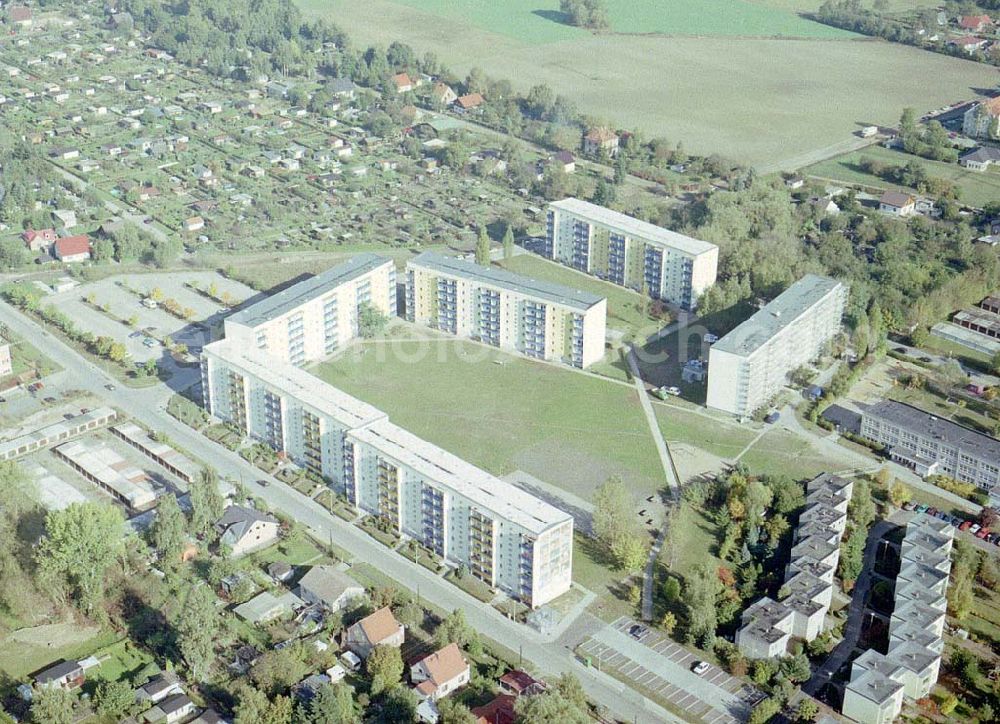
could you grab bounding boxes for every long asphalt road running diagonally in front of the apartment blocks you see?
[0,301,679,724]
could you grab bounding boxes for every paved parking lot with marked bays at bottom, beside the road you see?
[579,618,755,724]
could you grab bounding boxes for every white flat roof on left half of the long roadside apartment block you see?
[203,339,386,429]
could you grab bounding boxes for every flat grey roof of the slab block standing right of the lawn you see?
[712,274,842,357]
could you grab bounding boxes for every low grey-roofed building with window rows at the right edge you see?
[861,400,1000,505]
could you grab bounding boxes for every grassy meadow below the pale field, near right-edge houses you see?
[805,146,1000,206]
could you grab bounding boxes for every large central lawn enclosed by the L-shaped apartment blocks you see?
[312,339,663,497]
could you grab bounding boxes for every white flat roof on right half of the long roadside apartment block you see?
[350,419,572,535]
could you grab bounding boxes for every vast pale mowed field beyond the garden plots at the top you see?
[296,0,998,167]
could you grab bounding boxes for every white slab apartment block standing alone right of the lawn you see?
[706,274,847,417]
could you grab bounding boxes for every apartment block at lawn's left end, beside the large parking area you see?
[225,254,396,365]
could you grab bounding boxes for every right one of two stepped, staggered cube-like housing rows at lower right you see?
[843,514,955,724]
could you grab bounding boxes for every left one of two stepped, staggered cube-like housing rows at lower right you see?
[736,473,854,659]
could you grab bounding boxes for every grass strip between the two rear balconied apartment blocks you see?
[492,254,670,336]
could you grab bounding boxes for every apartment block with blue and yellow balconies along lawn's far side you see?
[406,252,608,367]
